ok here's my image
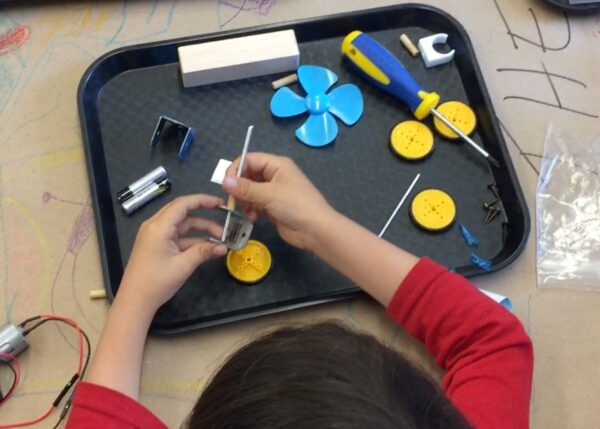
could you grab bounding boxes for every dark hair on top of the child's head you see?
[187,322,470,429]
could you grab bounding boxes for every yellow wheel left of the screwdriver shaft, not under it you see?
[390,121,433,161]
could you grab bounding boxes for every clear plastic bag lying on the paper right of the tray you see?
[536,125,600,290]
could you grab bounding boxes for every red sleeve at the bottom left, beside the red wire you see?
[66,382,167,429]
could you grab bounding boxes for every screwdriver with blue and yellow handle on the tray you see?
[342,31,500,167]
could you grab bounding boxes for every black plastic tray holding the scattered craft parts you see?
[78,4,529,333]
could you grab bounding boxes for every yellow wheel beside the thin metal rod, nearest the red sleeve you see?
[410,189,456,232]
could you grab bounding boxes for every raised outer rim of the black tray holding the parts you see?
[77,3,531,334]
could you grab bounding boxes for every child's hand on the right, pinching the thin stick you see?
[223,153,335,250]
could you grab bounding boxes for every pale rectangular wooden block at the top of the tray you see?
[177,30,300,88]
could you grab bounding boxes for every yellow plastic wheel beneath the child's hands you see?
[225,240,273,284]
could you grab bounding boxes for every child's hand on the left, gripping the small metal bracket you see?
[117,195,227,314]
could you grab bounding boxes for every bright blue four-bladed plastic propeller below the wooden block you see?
[271,66,363,147]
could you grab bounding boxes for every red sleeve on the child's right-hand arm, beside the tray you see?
[388,258,533,429]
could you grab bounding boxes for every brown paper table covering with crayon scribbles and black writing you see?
[0,0,600,428]
